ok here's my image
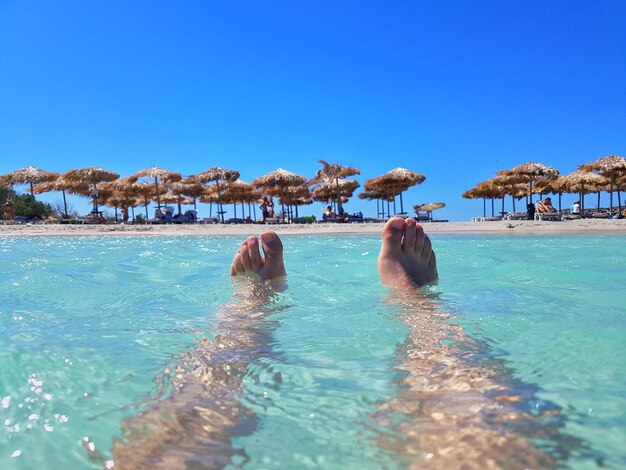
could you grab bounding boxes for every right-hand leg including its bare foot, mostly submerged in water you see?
[376,217,554,468]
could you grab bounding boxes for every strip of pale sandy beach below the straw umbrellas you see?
[0,219,626,236]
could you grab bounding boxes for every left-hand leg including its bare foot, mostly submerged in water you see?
[113,232,285,470]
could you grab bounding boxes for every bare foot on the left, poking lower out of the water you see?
[230,231,286,281]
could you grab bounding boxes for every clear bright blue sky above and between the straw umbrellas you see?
[0,0,626,220]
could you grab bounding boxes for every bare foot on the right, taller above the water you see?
[378,217,439,288]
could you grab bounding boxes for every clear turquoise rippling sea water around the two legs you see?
[0,235,626,469]
